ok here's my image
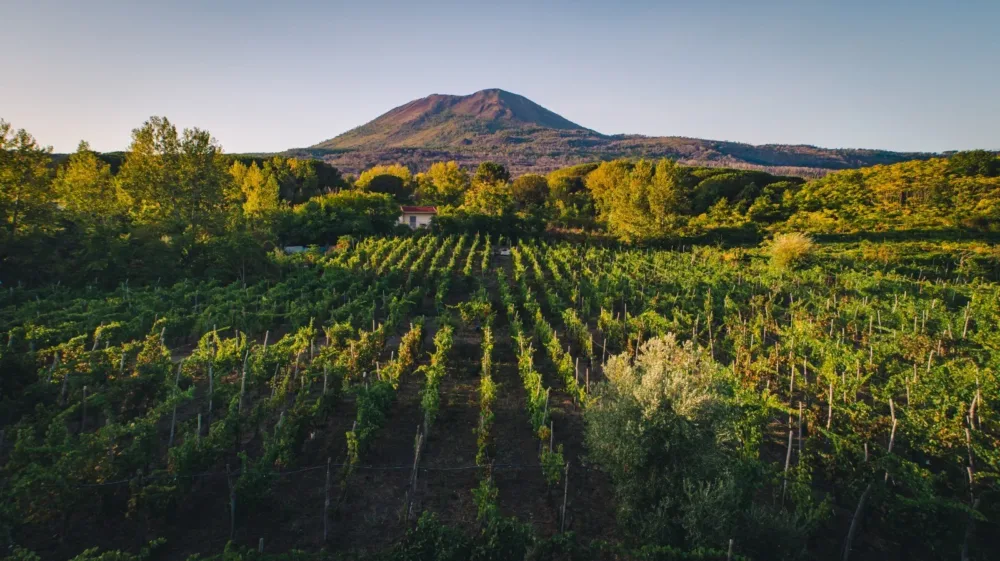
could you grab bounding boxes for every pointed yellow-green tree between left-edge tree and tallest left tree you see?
[53,141,123,225]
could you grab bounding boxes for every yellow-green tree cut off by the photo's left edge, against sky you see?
[0,120,52,237]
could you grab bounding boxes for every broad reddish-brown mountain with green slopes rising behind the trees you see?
[289,89,932,176]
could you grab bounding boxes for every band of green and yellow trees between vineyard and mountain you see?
[0,117,1000,286]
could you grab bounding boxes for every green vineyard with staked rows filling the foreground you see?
[0,234,1000,561]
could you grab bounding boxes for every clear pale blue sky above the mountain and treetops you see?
[0,0,1000,152]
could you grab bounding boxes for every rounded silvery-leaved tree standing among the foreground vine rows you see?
[584,335,725,543]
